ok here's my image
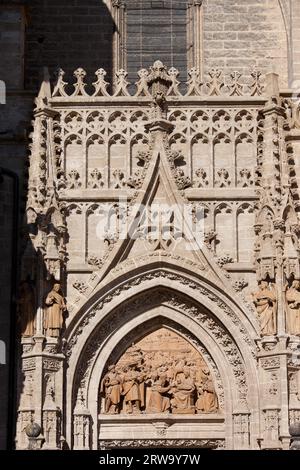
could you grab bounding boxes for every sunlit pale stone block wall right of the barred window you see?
[203,0,288,86]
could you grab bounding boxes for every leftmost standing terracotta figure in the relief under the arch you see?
[101,365,122,414]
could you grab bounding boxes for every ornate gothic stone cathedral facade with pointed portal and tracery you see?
[1,0,300,450]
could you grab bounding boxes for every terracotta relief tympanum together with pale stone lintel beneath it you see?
[99,328,224,440]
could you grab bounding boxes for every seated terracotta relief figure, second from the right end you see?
[171,366,196,414]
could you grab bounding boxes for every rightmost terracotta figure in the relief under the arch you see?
[196,367,218,413]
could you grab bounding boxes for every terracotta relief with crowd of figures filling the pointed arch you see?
[100,328,218,414]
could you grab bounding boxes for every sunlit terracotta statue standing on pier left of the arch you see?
[44,284,67,338]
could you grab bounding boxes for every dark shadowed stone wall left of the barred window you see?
[25,0,115,89]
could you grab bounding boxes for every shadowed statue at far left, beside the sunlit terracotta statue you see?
[17,282,35,337]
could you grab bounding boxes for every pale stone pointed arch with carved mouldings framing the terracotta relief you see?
[66,260,259,448]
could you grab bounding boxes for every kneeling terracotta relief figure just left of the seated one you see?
[146,374,171,413]
